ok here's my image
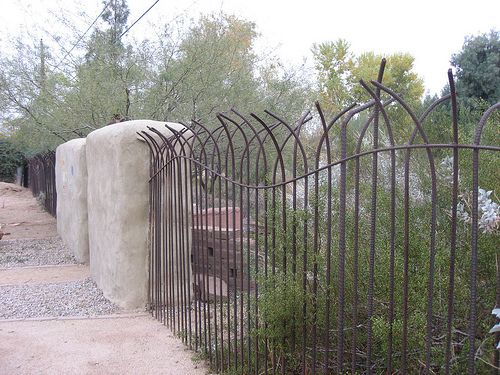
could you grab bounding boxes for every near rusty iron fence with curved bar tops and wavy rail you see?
[140,62,500,374]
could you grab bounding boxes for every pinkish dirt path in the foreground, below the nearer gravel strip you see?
[0,316,205,375]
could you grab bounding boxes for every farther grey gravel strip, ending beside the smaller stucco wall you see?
[0,237,76,268]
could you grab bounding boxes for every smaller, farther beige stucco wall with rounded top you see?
[56,138,89,263]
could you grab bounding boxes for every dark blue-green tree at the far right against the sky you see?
[451,30,500,104]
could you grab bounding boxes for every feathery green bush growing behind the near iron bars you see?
[248,152,500,374]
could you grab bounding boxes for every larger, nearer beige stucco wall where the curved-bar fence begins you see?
[86,120,188,308]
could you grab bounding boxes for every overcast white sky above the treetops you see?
[0,0,500,93]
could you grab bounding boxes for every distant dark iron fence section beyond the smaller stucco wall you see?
[28,151,57,217]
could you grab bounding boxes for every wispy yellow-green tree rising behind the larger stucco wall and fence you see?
[141,14,310,122]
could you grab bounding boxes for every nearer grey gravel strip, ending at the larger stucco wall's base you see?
[0,278,119,319]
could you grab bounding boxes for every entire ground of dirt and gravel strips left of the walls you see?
[0,183,207,375]
